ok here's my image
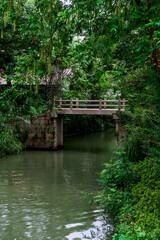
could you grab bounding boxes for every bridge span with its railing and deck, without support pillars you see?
[53,98,127,115]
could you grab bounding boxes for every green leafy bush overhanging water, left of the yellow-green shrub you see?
[98,151,134,221]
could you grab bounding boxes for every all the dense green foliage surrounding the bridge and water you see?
[0,0,160,240]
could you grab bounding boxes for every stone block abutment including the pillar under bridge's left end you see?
[10,111,63,150]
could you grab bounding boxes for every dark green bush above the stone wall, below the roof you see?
[0,84,48,117]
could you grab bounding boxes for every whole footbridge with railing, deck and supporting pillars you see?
[52,98,127,149]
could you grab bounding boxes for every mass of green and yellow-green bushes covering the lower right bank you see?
[96,149,160,240]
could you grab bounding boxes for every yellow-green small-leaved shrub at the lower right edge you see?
[132,158,160,239]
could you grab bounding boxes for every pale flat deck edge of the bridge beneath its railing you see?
[57,108,122,115]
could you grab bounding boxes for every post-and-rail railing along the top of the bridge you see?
[53,98,128,111]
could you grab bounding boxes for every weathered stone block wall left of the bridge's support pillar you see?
[11,111,56,149]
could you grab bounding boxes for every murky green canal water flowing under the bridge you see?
[0,130,115,240]
